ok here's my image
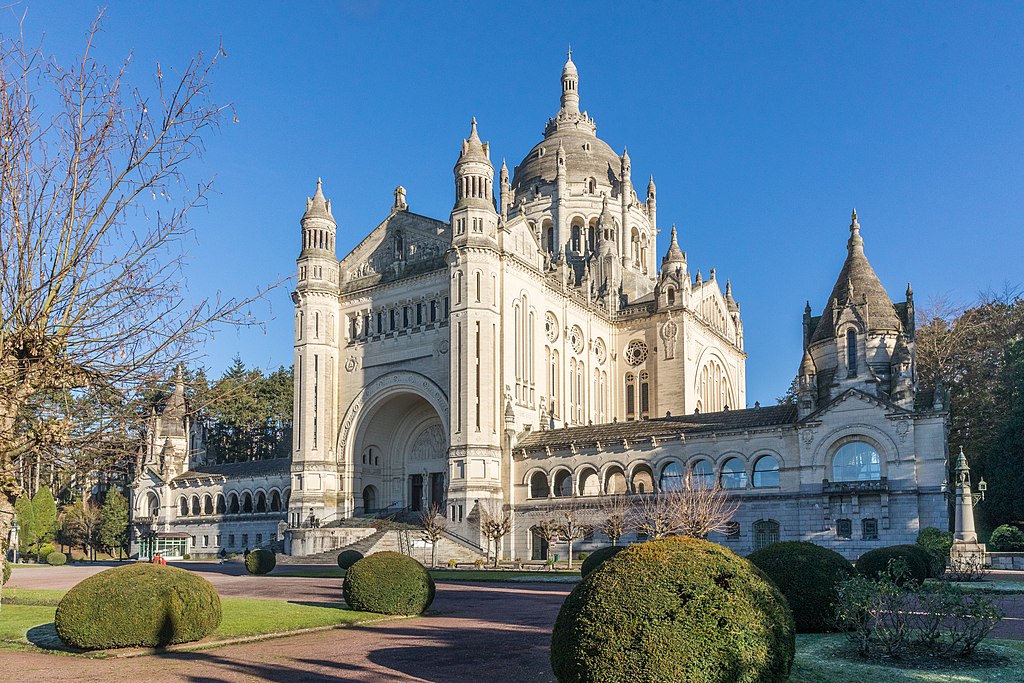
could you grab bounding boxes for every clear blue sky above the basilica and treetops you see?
[14,0,1024,404]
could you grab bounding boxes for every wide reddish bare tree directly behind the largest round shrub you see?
[634,476,738,539]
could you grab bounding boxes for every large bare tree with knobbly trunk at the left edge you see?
[0,12,272,538]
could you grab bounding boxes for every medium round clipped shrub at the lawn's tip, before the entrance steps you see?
[343,552,434,614]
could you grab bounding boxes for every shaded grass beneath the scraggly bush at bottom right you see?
[788,634,1024,683]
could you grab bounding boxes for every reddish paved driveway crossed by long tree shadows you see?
[6,563,1024,683]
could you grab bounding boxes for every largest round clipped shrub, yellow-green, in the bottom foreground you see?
[551,537,796,683]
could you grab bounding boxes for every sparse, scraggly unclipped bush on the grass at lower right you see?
[837,559,1005,657]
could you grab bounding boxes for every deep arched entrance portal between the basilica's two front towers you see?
[348,390,449,515]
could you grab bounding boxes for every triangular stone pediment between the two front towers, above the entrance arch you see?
[341,211,452,289]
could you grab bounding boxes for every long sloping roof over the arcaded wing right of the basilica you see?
[516,404,797,449]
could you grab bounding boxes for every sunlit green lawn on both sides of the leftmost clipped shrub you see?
[0,589,388,648]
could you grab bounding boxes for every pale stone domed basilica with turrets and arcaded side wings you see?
[132,56,947,560]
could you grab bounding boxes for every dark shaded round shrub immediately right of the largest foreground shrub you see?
[746,541,856,633]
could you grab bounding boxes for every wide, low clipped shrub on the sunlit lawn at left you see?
[53,563,220,649]
